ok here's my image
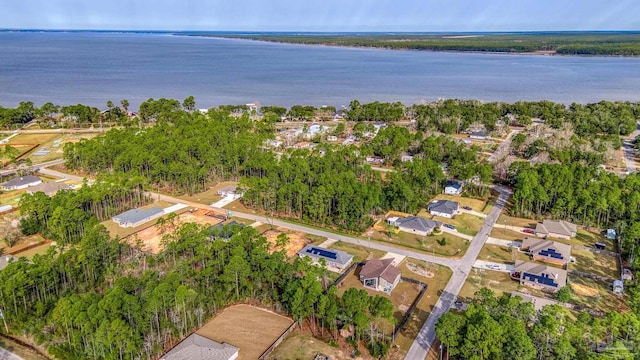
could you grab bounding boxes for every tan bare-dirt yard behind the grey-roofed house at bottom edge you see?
[196,304,293,360]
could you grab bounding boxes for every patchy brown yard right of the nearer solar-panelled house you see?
[567,275,629,314]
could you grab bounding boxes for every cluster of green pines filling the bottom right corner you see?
[436,288,640,360]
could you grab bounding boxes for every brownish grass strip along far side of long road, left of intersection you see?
[371,230,469,256]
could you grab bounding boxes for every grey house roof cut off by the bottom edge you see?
[160,334,240,360]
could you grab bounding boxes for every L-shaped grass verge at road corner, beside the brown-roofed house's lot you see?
[394,258,452,351]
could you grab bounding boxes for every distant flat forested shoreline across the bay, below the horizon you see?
[211,32,640,56]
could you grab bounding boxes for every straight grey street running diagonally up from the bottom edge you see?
[405,187,510,360]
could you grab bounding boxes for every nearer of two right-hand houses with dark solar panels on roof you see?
[511,260,567,292]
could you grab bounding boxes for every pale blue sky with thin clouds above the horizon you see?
[0,0,640,32]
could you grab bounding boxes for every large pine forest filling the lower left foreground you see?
[0,181,394,359]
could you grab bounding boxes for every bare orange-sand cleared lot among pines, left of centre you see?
[122,208,222,254]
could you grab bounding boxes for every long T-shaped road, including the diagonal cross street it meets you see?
[38,162,511,360]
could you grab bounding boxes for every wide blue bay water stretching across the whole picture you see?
[0,32,640,108]
